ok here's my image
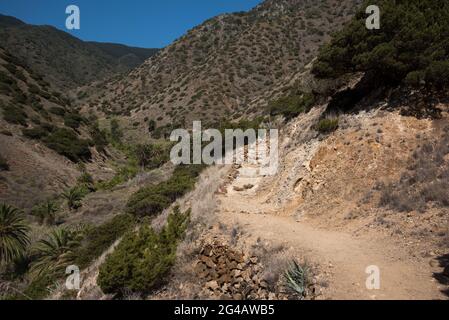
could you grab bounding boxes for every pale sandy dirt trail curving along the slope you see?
[215,164,444,299]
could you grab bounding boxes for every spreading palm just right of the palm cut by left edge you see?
[31,228,80,277]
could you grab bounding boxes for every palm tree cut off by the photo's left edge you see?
[0,204,30,263]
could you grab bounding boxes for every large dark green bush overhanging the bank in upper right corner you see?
[312,0,449,86]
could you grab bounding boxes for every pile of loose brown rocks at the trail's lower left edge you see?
[195,243,279,300]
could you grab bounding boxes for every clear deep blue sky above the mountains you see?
[0,0,262,48]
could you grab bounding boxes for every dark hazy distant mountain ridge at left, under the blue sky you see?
[0,15,158,88]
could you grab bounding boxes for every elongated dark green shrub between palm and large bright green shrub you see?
[75,214,135,268]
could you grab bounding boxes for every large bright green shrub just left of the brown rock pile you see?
[98,208,190,295]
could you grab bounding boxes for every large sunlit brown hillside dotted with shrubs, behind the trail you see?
[86,0,359,132]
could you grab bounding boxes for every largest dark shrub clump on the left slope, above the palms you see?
[44,128,92,162]
